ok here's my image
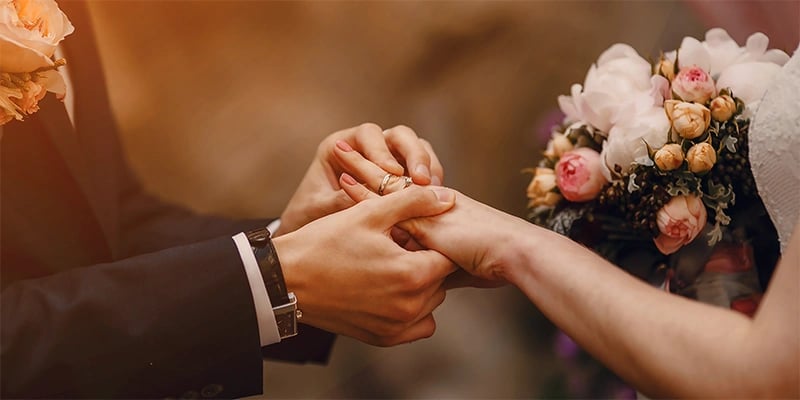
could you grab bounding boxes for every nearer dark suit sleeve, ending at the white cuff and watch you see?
[0,237,262,398]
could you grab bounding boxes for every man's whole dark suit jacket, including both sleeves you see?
[0,2,333,398]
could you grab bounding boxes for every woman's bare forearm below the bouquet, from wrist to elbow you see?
[505,226,785,397]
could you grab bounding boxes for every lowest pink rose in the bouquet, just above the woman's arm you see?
[653,196,707,254]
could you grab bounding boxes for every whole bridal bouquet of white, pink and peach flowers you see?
[528,29,789,304]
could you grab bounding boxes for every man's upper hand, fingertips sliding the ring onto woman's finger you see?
[276,124,443,236]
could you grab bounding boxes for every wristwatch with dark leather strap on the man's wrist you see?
[245,228,303,339]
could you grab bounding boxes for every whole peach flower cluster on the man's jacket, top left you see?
[0,0,75,126]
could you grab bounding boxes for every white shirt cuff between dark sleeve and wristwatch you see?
[233,233,281,347]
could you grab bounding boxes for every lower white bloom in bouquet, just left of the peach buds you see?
[600,107,670,182]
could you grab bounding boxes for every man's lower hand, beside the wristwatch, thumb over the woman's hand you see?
[273,186,457,346]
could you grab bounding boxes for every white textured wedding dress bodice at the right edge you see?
[749,47,800,253]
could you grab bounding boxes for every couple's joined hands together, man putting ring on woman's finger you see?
[273,124,527,346]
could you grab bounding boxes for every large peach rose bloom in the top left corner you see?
[0,0,75,72]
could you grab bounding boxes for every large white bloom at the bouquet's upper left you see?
[558,44,652,133]
